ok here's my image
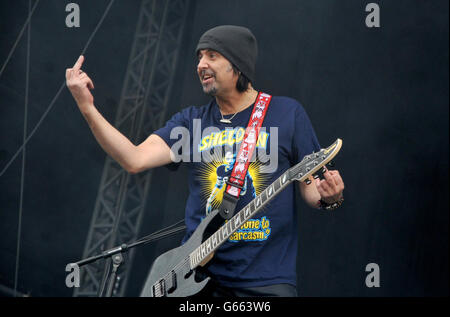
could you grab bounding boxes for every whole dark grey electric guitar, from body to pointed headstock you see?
[141,139,342,297]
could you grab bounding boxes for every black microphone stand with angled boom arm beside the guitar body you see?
[74,222,186,297]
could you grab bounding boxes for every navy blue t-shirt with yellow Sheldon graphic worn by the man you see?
[154,96,320,287]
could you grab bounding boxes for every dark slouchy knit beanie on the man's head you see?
[195,25,258,82]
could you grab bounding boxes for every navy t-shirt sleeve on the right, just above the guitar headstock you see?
[292,103,320,164]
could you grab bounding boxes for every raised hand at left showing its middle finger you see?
[66,55,94,111]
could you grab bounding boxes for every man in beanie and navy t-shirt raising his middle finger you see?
[66,25,344,296]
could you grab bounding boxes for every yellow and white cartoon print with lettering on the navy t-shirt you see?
[197,128,271,242]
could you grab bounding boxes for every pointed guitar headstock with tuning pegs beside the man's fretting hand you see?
[289,139,342,183]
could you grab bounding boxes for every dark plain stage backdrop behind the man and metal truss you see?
[0,0,449,297]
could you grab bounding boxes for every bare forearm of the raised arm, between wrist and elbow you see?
[80,105,138,173]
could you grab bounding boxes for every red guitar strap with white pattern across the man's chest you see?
[219,92,272,219]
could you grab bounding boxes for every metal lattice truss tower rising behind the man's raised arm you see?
[73,0,189,296]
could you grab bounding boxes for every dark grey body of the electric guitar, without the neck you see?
[140,210,223,297]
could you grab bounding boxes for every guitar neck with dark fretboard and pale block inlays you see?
[189,170,292,269]
